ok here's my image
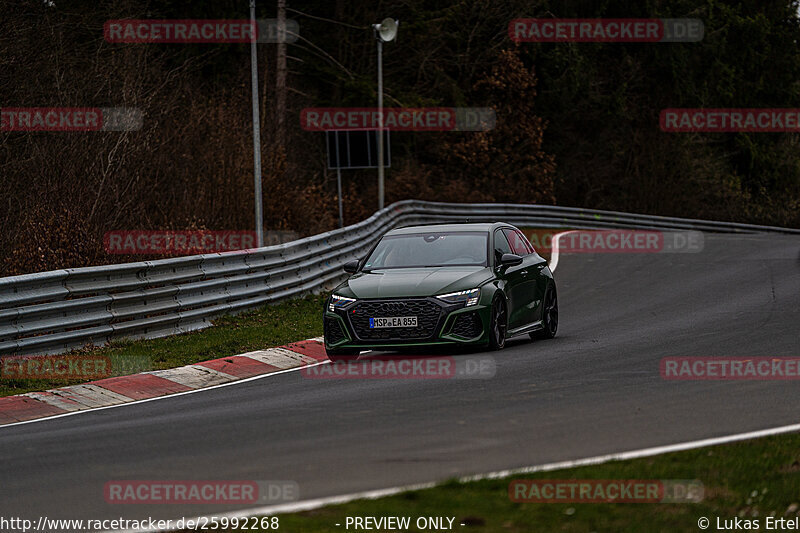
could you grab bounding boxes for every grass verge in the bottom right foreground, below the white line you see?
[264,434,800,533]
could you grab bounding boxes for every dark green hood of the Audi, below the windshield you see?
[336,266,492,299]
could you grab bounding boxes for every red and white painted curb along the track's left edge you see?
[0,338,328,426]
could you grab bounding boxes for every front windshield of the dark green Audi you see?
[364,231,487,270]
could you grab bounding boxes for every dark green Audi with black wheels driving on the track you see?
[324,223,558,361]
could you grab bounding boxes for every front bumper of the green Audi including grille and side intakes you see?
[324,297,490,349]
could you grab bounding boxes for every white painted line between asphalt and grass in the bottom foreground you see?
[125,424,800,533]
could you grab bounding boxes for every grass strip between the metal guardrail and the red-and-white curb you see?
[0,295,325,397]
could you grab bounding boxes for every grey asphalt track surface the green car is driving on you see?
[0,234,800,519]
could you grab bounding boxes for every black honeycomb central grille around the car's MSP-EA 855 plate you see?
[347,300,444,341]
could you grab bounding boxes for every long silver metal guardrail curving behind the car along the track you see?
[0,200,800,355]
